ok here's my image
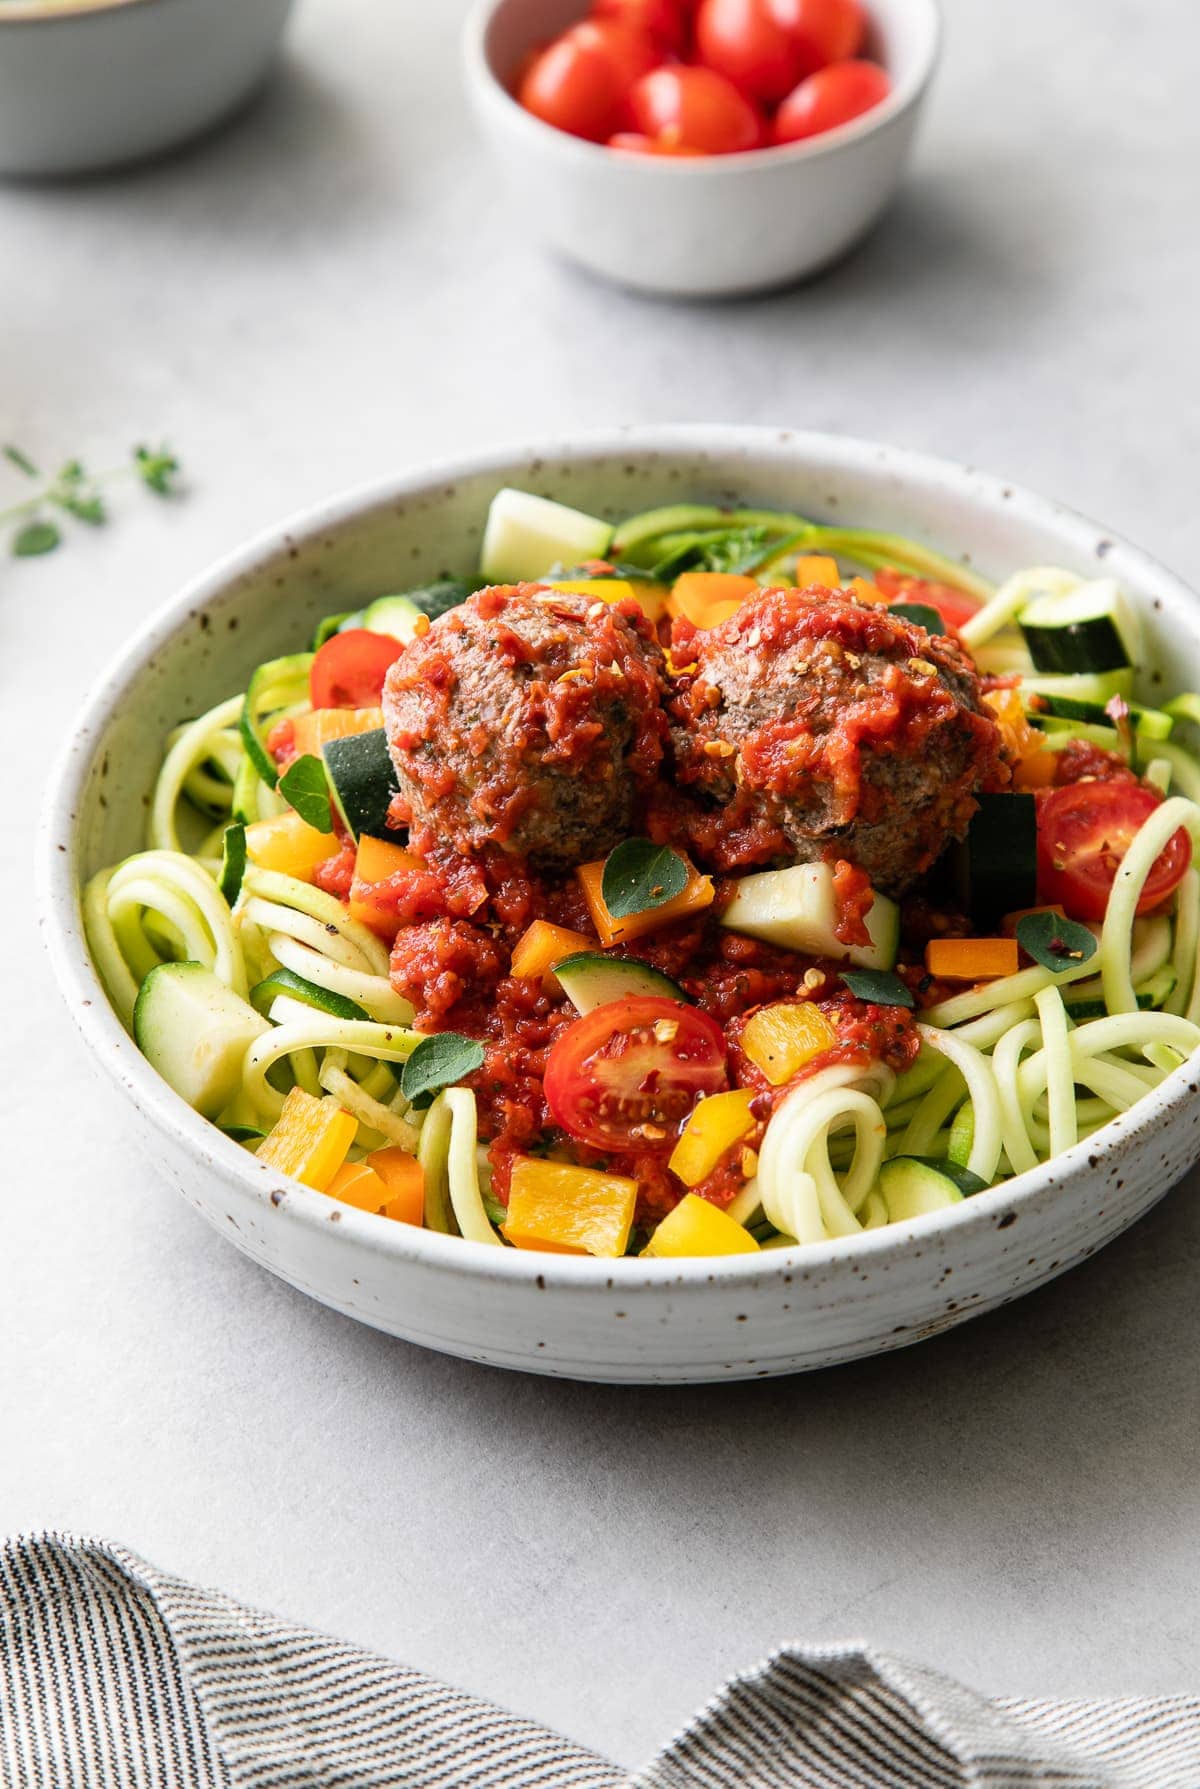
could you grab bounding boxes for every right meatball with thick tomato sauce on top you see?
[671,587,1009,895]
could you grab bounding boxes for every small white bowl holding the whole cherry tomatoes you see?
[465,0,941,297]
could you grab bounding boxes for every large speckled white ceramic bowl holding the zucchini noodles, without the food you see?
[39,428,1200,1383]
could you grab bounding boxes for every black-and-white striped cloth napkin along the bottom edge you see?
[0,1535,1200,1789]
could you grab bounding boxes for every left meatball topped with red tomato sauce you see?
[383,585,667,869]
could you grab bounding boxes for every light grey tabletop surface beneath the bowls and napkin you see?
[0,0,1200,1762]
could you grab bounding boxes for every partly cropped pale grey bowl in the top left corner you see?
[0,0,292,175]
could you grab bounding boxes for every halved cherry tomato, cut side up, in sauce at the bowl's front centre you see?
[545,996,728,1149]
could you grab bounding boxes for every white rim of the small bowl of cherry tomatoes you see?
[463,0,946,179]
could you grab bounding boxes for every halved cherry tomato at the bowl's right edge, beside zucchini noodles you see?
[1037,782,1191,920]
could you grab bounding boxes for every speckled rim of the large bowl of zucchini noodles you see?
[36,422,1200,1295]
